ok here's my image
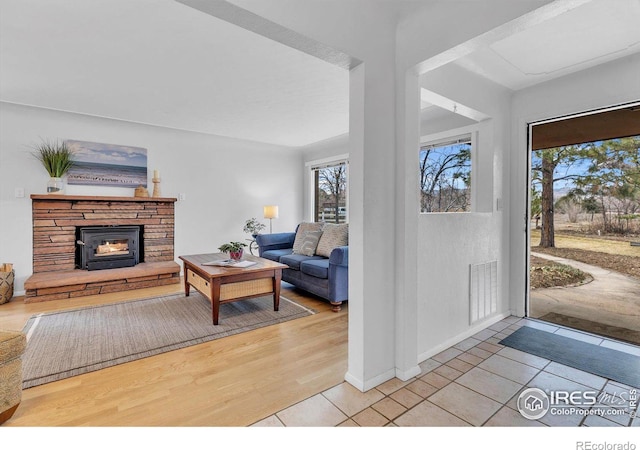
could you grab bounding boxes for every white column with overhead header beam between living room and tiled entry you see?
[232,0,397,390]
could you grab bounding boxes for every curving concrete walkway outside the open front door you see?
[529,252,640,331]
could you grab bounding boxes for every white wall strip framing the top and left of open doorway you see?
[509,54,640,316]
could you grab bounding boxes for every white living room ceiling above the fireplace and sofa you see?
[0,0,349,147]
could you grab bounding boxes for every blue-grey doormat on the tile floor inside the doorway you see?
[500,326,640,387]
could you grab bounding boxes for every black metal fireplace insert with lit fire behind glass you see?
[76,225,144,270]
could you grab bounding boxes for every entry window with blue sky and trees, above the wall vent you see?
[420,134,472,213]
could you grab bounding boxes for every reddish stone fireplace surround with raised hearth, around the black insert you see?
[24,194,180,303]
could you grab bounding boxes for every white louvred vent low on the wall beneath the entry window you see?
[469,261,498,324]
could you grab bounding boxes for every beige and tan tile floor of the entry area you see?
[252,317,640,427]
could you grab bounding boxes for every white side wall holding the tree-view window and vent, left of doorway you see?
[415,64,512,360]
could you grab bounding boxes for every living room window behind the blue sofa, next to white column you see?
[311,160,348,223]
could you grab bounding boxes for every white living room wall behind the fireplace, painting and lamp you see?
[0,102,303,291]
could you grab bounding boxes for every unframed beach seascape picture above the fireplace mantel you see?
[65,140,147,188]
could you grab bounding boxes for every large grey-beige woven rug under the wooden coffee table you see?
[22,291,314,389]
